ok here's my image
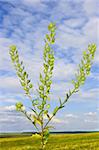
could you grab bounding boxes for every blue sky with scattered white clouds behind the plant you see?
[0,0,99,132]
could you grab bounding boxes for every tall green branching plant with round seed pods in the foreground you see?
[10,23,96,149]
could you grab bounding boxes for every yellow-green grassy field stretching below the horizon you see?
[0,133,99,150]
